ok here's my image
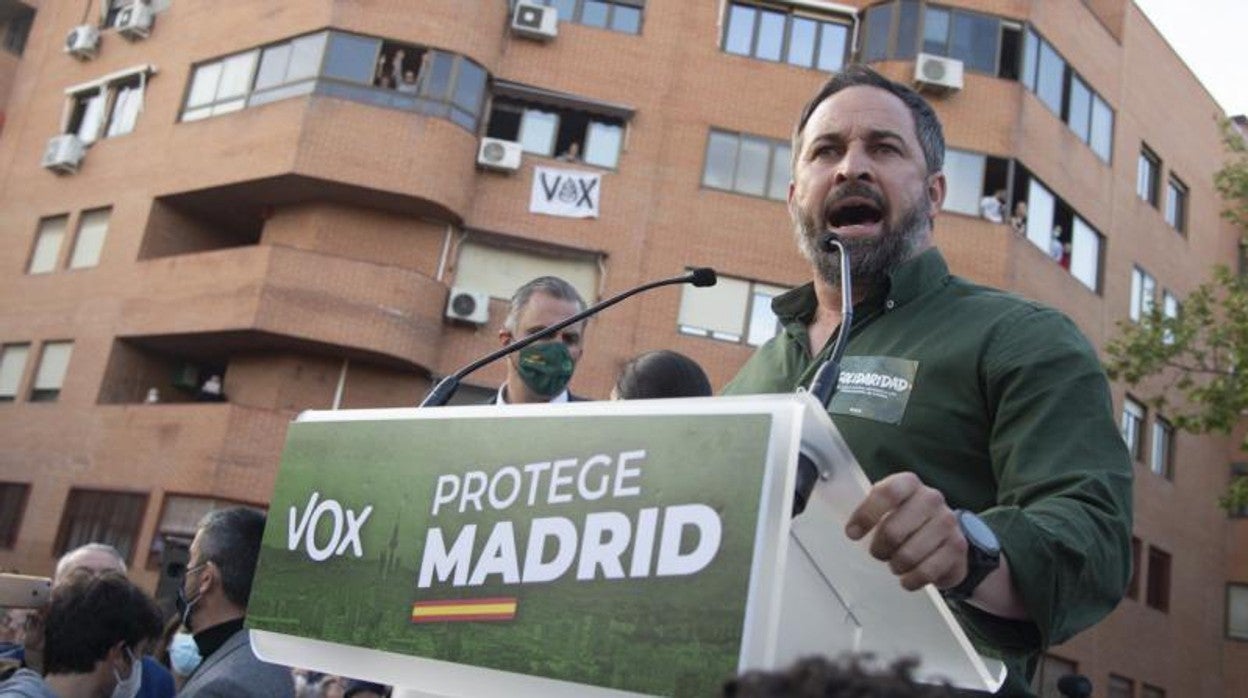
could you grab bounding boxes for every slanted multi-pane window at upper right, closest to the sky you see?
[1021,29,1113,162]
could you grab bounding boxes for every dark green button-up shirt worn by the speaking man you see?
[724,248,1132,694]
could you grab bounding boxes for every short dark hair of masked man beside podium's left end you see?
[200,507,265,608]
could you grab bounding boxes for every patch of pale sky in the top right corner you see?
[1136,0,1248,116]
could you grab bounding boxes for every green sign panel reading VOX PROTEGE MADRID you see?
[247,408,771,696]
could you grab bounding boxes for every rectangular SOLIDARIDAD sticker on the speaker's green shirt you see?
[827,356,919,425]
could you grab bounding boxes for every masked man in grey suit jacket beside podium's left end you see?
[177,507,295,698]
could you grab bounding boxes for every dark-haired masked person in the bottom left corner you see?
[0,568,161,698]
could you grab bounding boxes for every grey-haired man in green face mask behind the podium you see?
[489,276,585,405]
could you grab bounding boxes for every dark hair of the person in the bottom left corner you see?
[44,569,161,674]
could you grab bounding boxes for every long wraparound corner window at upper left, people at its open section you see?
[181,31,487,134]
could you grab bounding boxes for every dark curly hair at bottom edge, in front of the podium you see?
[723,656,956,698]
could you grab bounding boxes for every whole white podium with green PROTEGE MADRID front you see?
[247,395,1005,698]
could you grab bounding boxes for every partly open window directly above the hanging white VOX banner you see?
[485,89,631,170]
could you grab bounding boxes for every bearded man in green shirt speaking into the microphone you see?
[725,66,1132,696]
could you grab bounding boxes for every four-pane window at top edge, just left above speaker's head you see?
[724,2,851,72]
